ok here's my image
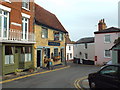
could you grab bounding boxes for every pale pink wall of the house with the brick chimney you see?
[95,33,118,65]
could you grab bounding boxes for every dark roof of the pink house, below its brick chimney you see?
[94,27,120,34]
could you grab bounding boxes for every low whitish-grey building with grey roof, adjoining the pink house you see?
[74,37,95,64]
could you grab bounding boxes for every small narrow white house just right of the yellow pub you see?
[66,34,75,61]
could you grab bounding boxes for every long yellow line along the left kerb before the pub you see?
[0,66,70,84]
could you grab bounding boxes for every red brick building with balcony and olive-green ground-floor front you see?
[0,0,35,75]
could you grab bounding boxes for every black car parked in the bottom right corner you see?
[88,65,120,90]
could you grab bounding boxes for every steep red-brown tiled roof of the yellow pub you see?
[35,4,67,33]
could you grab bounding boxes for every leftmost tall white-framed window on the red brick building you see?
[0,9,9,38]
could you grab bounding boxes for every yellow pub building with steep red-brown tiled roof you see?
[34,4,67,67]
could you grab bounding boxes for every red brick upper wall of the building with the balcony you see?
[1,0,34,32]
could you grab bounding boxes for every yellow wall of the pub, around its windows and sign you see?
[34,25,65,67]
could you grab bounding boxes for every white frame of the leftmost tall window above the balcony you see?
[0,9,9,39]
